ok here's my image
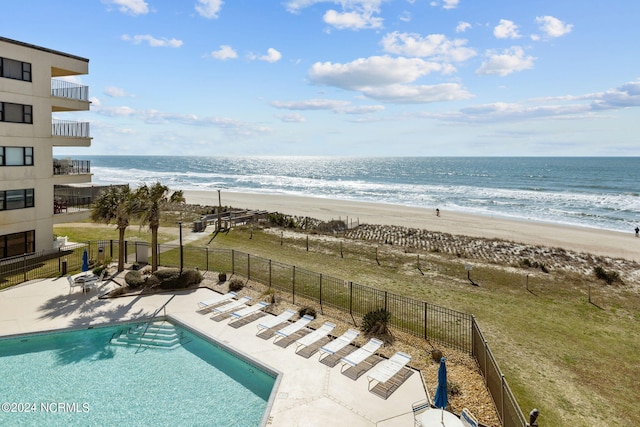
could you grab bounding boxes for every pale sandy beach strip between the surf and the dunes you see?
[184,191,640,261]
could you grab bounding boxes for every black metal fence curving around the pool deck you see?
[0,240,527,427]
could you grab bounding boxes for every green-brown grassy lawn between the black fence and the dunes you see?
[55,226,640,426]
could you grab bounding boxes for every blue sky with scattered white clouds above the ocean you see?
[0,0,640,156]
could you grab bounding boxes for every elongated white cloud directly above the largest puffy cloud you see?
[382,31,476,62]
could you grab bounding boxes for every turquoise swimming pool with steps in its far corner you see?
[0,325,276,427]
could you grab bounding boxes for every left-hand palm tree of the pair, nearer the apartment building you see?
[91,185,135,271]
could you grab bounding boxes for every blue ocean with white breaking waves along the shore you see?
[83,156,640,232]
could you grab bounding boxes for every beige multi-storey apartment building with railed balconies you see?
[0,37,91,259]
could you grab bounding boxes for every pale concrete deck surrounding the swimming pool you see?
[0,277,427,427]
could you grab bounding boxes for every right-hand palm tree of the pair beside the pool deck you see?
[136,182,185,271]
